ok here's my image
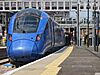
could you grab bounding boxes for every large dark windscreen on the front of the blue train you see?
[14,14,40,33]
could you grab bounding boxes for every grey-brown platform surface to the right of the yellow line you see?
[58,47,100,75]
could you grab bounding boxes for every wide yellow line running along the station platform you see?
[41,46,73,75]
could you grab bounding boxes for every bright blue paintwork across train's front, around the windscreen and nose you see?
[7,8,48,61]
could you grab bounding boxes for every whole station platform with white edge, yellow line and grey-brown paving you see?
[3,46,100,75]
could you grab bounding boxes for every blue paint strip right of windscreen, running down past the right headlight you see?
[36,12,48,54]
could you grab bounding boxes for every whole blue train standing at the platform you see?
[7,8,65,62]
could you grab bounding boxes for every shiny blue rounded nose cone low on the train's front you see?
[9,40,37,58]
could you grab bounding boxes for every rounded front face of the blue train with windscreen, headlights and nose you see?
[7,9,46,62]
